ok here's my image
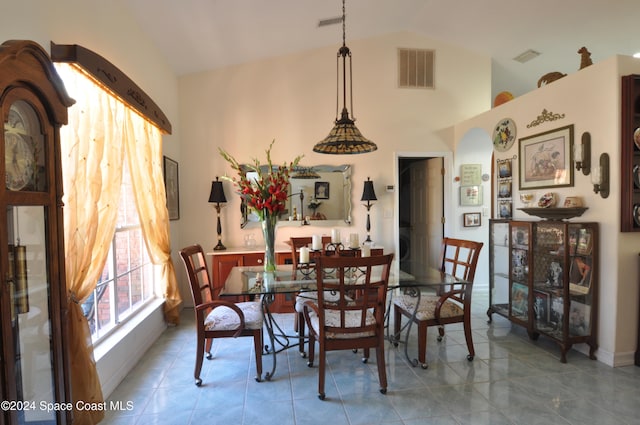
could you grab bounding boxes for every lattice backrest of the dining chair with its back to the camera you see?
[316,254,393,338]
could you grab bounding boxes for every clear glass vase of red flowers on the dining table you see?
[218,140,302,273]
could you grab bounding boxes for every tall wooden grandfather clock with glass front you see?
[0,40,74,424]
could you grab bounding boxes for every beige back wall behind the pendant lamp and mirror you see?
[179,33,491,251]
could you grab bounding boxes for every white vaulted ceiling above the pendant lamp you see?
[123,0,640,95]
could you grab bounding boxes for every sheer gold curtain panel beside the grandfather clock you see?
[58,65,125,424]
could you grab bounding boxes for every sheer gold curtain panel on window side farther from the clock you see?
[125,108,182,324]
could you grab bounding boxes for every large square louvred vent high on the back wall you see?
[398,48,435,89]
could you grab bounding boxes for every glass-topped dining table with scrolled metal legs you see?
[220,264,469,381]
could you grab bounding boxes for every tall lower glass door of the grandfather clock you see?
[7,206,55,424]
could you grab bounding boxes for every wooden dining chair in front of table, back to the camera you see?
[303,254,393,400]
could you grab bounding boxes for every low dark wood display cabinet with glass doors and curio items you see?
[487,220,598,363]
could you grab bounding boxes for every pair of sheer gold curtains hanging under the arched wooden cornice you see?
[56,64,180,424]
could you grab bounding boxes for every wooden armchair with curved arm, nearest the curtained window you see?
[180,245,263,386]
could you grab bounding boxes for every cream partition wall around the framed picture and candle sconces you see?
[455,57,640,366]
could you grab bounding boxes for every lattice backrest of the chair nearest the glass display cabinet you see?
[440,238,484,282]
